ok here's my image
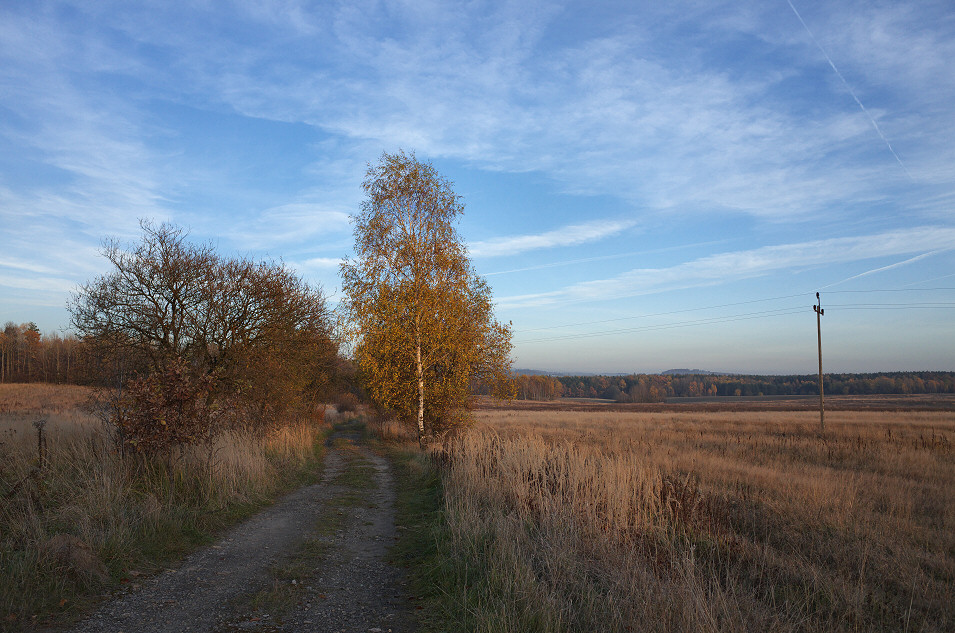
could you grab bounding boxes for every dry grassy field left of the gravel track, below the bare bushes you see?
[0,384,325,631]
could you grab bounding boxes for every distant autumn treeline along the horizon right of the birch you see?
[514,371,955,402]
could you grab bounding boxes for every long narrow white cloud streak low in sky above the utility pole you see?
[498,227,955,309]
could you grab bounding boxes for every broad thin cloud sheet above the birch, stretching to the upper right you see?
[194,3,950,220]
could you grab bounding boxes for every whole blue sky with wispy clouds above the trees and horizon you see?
[0,0,955,373]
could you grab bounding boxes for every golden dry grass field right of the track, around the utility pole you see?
[445,411,955,631]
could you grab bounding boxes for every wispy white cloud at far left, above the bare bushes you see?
[0,11,168,232]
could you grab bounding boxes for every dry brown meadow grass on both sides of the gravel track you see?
[9,384,955,633]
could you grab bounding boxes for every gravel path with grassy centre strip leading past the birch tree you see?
[61,433,415,633]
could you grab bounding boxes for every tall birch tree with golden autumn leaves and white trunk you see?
[341,152,511,441]
